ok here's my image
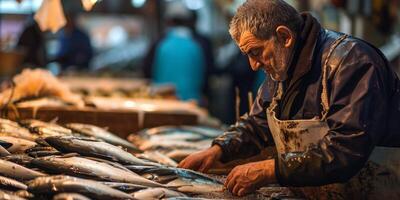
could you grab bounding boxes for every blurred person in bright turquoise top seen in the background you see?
[144,4,206,102]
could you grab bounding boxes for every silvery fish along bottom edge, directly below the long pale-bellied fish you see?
[27,175,134,200]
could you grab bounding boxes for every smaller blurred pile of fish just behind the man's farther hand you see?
[128,126,223,167]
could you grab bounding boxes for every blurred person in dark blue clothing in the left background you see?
[54,13,93,70]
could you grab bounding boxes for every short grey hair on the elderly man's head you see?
[229,0,303,42]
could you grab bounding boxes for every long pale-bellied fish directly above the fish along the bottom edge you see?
[32,156,165,187]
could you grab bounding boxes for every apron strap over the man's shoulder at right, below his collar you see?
[321,34,348,120]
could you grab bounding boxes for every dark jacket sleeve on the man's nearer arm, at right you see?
[275,43,390,186]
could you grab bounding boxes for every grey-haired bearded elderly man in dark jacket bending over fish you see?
[179,0,400,197]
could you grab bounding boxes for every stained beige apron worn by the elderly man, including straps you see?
[266,35,400,199]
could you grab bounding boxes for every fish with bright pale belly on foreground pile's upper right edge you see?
[65,123,142,153]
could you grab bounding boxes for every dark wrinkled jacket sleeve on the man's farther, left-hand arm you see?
[212,78,274,162]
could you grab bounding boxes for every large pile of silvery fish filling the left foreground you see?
[0,119,223,200]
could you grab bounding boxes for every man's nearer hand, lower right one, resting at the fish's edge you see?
[224,160,276,196]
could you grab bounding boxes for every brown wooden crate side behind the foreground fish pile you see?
[7,107,198,138]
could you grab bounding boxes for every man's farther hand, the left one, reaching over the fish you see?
[178,145,222,173]
